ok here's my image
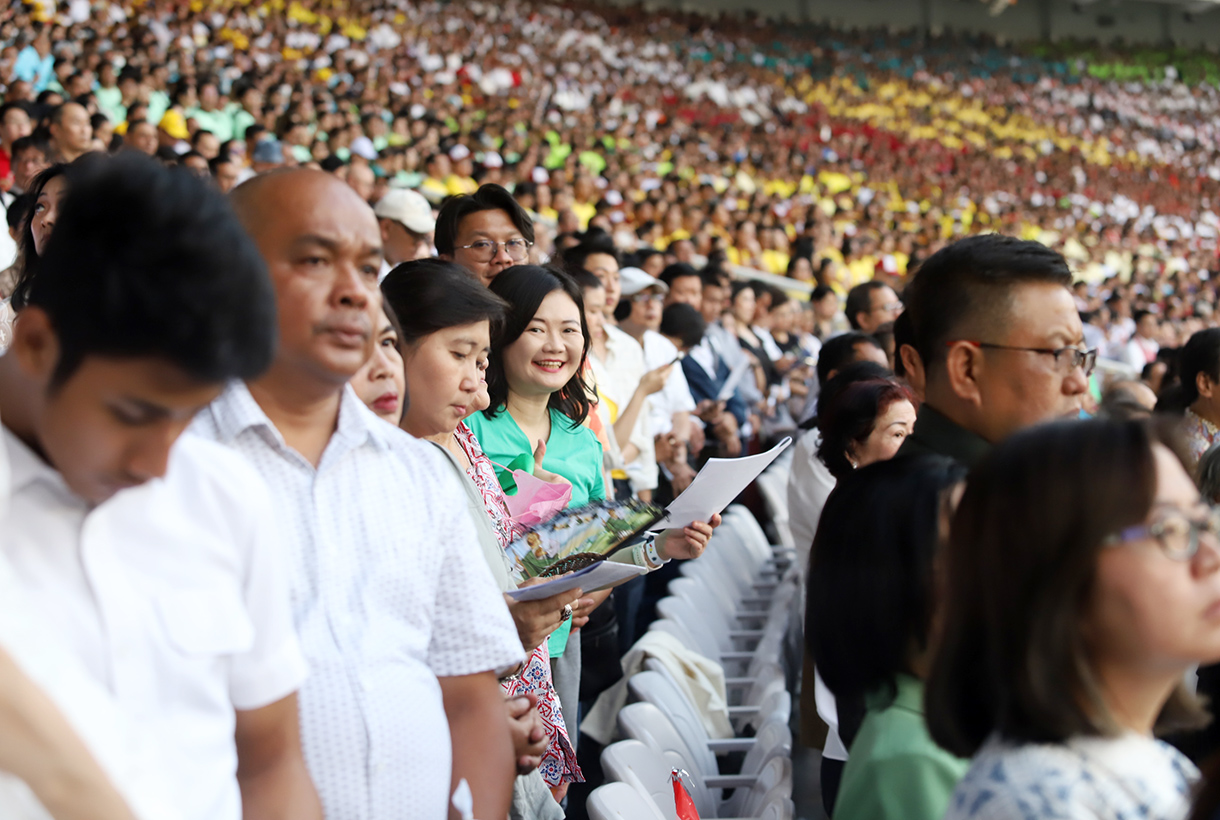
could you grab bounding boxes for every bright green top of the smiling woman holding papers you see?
[466,406,606,506]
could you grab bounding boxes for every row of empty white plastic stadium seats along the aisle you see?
[587,506,799,820]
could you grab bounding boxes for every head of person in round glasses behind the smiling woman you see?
[436,184,534,286]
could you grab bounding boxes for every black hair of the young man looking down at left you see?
[15,154,277,384]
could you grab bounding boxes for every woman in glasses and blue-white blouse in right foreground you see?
[926,421,1220,820]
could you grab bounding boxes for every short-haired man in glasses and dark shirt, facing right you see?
[900,234,1097,466]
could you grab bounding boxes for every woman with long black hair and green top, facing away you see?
[805,455,969,820]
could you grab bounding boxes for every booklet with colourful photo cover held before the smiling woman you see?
[508,499,665,580]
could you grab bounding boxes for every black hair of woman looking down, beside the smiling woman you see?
[381,259,509,348]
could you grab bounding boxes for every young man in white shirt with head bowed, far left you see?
[0,155,321,820]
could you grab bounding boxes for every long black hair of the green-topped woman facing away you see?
[805,455,966,744]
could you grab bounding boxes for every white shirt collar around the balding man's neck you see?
[209,382,393,470]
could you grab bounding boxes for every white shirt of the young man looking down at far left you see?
[0,430,306,820]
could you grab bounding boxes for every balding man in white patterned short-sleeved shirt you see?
[194,170,523,820]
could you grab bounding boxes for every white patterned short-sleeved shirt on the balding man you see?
[192,383,523,820]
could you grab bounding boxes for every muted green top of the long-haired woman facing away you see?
[832,675,970,820]
